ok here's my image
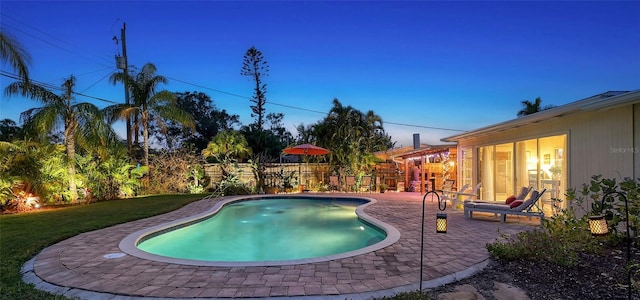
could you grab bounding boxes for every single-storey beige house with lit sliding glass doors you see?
[442,90,640,214]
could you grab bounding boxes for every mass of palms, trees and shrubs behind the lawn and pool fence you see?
[0,41,393,209]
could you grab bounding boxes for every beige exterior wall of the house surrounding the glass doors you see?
[457,104,640,213]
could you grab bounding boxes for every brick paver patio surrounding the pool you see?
[23,193,539,299]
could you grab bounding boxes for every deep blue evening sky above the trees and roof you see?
[0,0,640,146]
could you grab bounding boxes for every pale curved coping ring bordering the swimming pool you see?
[119,194,401,267]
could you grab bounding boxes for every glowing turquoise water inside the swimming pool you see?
[137,198,386,262]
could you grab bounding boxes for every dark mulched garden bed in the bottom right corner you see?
[426,247,640,300]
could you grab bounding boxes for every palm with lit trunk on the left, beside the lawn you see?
[5,75,114,201]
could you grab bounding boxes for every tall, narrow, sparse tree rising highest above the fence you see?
[240,47,269,131]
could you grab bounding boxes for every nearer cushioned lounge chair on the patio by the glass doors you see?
[464,189,546,224]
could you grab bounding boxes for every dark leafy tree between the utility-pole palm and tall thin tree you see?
[167,92,240,153]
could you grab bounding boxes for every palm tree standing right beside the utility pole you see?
[105,63,195,166]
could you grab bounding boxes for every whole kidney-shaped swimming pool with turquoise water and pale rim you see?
[120,196,400,266]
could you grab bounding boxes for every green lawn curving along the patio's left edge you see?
[0,195,204,299]
